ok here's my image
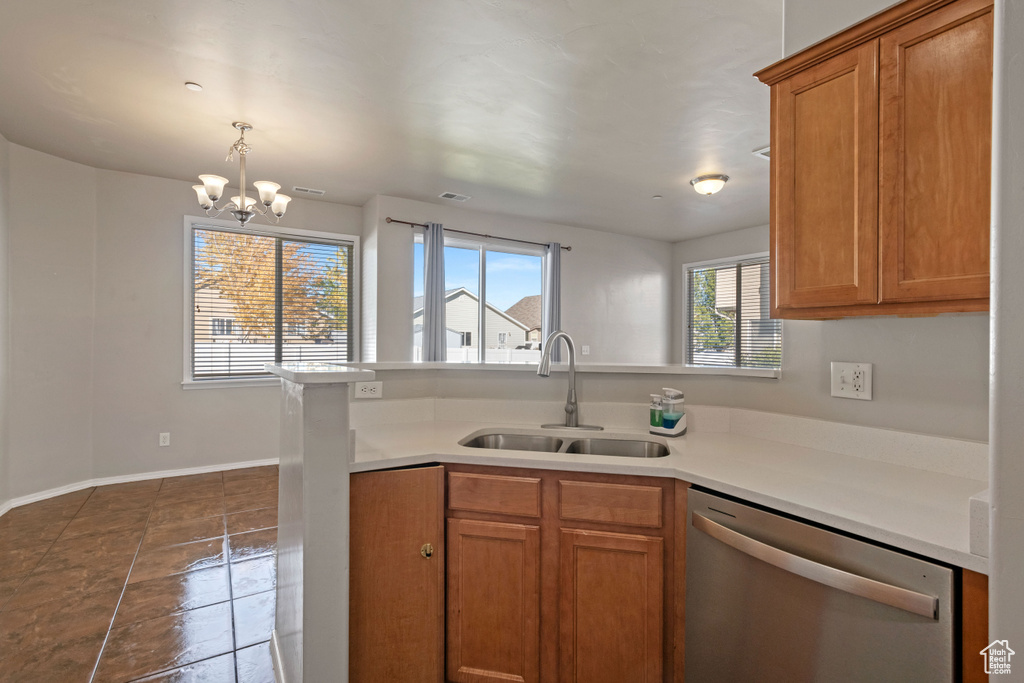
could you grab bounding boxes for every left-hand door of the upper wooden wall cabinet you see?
[771,41,879,309]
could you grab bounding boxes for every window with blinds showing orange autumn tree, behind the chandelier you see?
[190,225,353,381]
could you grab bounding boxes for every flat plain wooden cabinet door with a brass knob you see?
[350,467,444,683]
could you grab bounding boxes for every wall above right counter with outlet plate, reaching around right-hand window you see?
[674,225,988,441]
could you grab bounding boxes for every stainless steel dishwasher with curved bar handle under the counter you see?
[685,489,954,683]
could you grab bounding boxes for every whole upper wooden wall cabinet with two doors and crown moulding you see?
[757,0,992,318]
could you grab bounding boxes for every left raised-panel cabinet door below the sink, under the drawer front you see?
[447,519,541,683]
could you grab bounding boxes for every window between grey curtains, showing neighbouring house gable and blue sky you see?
[413,233,545,362]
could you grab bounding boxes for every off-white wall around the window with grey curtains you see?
[364,196,673,365]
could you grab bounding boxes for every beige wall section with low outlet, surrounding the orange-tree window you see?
[93,171,361,483]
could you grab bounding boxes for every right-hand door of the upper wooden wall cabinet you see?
[880,0,992,301]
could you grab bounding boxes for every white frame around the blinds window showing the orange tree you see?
[181,215,361,389]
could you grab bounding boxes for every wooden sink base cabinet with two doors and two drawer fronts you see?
[446,465,685,683]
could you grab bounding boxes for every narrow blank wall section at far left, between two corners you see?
[7,144,96,498]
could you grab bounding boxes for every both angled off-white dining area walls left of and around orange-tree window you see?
[0,144,361,503]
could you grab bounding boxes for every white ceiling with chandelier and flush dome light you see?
[0,0,782,241]
